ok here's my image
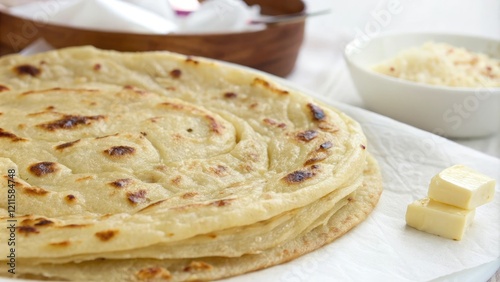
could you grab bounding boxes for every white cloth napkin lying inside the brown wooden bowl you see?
[5,0,264,34]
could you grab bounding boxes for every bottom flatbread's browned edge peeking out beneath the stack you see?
[16,157,382,281]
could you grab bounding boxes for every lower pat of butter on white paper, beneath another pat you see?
[406,198,476,240]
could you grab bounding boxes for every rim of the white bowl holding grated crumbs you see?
[343,32,500,92]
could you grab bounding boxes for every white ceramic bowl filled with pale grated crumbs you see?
[344,33,500,138]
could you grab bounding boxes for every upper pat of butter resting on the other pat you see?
[428,165,496,209]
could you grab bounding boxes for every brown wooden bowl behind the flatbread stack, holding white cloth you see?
[0,0,305,76]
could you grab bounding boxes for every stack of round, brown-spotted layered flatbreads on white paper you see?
[0,47,382,281]
